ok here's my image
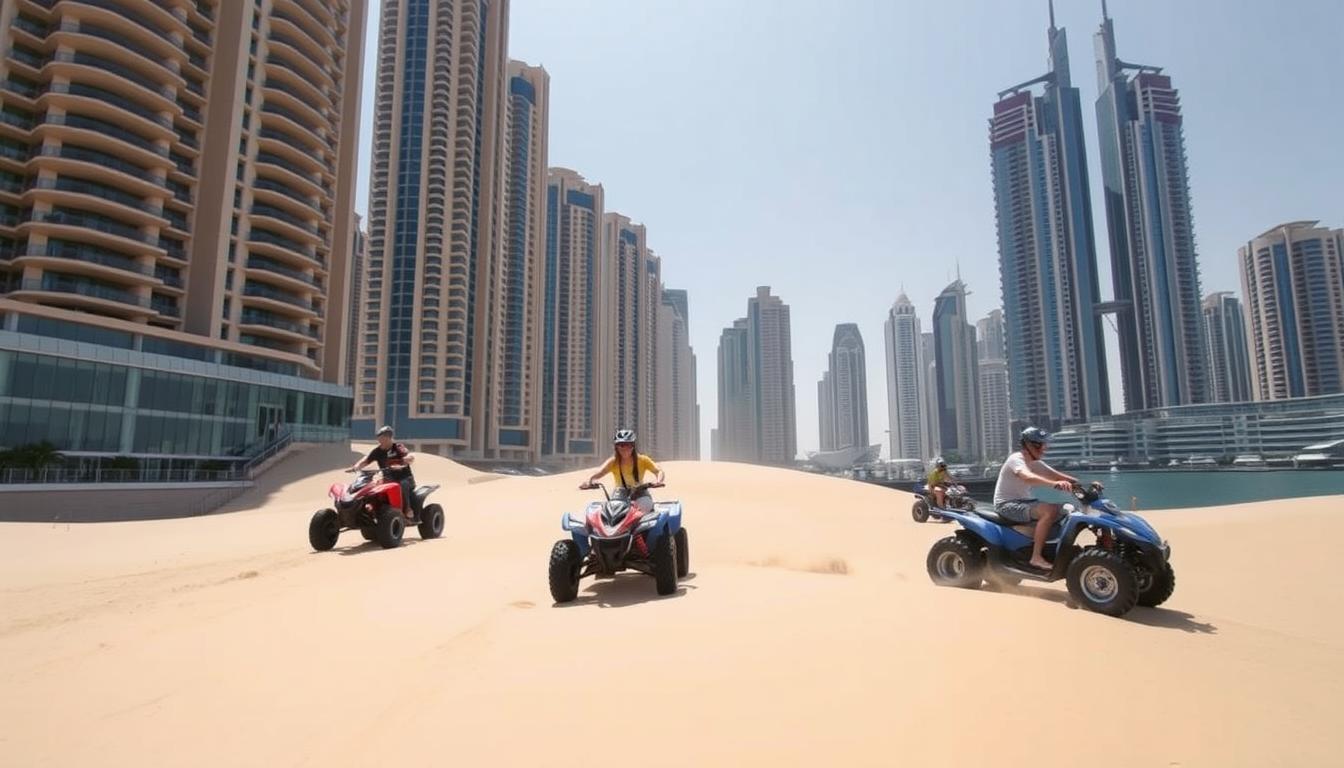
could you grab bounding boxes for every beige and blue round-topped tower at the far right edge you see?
[1236,221,1344,399]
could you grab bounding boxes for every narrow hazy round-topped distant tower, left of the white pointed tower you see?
[818,323,868,451]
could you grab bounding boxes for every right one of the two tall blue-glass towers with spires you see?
[1097,3,1210,410]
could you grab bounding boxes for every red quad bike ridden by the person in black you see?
[308,465,444,551]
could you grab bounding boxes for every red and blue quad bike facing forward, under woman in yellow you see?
[550,483,691,603]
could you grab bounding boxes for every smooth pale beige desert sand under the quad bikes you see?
[0,448,1344,767]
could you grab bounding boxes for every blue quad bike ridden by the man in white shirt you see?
[927,483,1176,616]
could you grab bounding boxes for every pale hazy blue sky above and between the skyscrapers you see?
[356,0,1344,459]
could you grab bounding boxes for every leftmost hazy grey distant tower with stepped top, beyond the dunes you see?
[716,286,798,464]
